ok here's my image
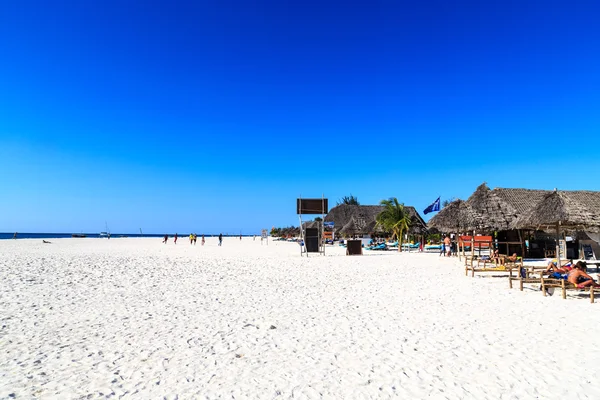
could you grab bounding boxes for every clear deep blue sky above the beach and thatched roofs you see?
[0,0,600,233]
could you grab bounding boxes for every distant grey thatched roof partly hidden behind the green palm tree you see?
[325,204,427,235]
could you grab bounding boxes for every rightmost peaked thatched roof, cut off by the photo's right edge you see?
[512,190,600,232]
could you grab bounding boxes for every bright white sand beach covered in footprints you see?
[0,238,600,399]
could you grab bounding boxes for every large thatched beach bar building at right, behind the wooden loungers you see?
[428,183,600,258]
